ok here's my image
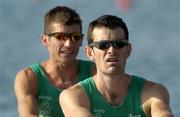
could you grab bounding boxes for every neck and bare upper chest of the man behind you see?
[43,61,78,88]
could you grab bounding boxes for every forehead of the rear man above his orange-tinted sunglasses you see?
[49,23,81,33]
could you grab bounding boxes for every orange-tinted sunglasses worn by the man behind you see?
[47,32,83,42]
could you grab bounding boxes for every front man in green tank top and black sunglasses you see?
[60,15,173,117]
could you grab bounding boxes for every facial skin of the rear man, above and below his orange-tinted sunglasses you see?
[47,23,81,63]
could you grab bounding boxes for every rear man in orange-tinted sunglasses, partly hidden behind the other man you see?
[15,6,95,117]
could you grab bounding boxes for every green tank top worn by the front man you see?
[80,76,146,117]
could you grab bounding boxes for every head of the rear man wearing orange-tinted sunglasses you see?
[42,6,83,62]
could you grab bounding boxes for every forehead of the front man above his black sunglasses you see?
[92,27,125,41]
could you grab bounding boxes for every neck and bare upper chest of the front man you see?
[94,74,130,105]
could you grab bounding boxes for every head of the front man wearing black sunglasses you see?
[85,15,131,74]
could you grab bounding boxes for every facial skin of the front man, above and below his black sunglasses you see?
[92,27,126,74]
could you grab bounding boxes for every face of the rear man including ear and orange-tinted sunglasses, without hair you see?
[42,23,82,63]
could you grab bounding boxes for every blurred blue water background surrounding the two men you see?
[0,0,180,117]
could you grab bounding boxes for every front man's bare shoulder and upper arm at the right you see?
[141,81,173,117]
